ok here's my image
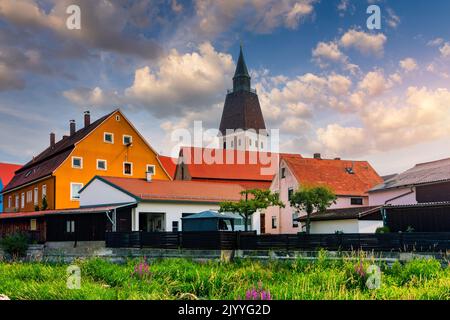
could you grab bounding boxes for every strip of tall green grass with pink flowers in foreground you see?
[0,252,450,300]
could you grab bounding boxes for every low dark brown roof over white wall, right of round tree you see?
[297,206,382,222]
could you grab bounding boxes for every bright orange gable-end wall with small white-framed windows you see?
[53,111,170,209]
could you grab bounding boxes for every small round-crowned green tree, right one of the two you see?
[289,186,337,234]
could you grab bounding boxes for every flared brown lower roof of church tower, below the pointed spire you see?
[219,91,266,135]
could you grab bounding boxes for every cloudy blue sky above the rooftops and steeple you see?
[0,0,450,175]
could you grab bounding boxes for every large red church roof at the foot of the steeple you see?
[180,147,301,182]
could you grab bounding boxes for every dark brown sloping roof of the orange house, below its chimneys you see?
[3,110,117,192]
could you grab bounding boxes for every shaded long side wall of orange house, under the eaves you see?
[3,177,55,212]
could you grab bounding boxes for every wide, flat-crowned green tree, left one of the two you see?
[219,189,284,231]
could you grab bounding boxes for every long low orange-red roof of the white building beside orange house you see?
[98,177,243,203]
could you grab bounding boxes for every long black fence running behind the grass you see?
[106,231,450,252]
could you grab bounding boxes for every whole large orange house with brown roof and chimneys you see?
[3,110,171,212]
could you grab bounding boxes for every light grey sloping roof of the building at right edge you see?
[370,158,450,191]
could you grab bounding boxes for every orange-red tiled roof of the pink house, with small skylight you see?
[282,156,383,196]
